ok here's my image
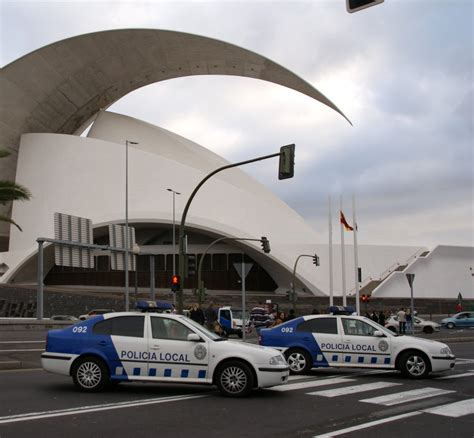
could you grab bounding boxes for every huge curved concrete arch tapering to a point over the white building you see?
[0,29,348,245]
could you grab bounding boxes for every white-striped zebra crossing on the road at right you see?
[269,370,474,418]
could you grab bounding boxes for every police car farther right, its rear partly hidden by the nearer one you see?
[259,315,456,379]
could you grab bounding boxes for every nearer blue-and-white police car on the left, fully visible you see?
[41,302,289,397]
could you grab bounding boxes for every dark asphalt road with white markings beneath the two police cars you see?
[0,342,474,438]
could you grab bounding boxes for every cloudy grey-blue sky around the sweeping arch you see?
[0,0,474,248]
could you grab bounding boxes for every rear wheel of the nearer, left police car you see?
[71,357,109,392]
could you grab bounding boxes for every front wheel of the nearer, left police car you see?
[215,361,254,397]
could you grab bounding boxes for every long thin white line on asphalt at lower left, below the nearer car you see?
[0,394,208,424]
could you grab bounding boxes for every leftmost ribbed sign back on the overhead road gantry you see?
[54,213,94,268]
